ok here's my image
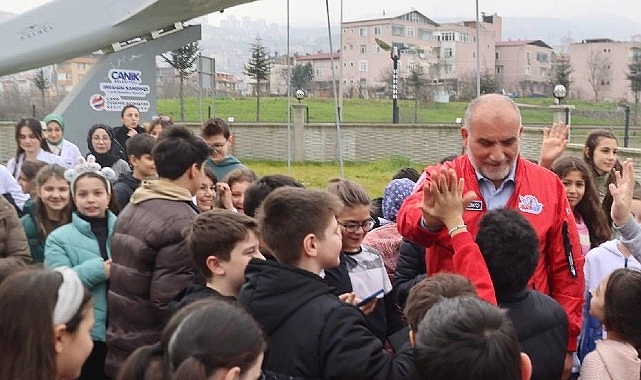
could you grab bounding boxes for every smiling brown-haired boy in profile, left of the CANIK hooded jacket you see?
[174,209,264,310]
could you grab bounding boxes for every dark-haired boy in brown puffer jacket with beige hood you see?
[105,126,211,378]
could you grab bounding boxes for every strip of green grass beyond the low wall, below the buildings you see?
[158,97,623,126]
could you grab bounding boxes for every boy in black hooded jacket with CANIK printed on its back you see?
[238,187,413,380]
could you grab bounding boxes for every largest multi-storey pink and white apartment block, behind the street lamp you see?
[341,11,502,97]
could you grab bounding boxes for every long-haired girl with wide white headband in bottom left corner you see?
[0,268,93,380]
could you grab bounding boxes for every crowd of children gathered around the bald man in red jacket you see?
[0,99,641,380]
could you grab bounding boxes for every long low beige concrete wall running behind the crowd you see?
[5,122,641,175]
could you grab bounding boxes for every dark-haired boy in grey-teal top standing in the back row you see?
[200,118,245,180]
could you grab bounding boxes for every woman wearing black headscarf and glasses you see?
[87,124,131,178]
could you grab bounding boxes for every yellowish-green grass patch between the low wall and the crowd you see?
[243,156,423,198]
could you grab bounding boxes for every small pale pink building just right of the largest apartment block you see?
[495,40,553,96]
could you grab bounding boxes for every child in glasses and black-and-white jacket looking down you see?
[325,179,406,342]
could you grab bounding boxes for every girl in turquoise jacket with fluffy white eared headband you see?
[44,155,116,380]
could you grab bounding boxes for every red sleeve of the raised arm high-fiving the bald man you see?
[451,232,496,305]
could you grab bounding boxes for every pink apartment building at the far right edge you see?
[569,36,641,101]
